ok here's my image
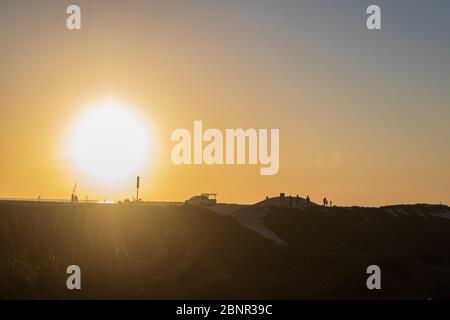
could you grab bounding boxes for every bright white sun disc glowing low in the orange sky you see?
[69,100,150,185]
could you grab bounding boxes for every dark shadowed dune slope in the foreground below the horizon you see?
[0,203,450,299]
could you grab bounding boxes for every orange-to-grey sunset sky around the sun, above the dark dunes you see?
[0,1,450,205]
